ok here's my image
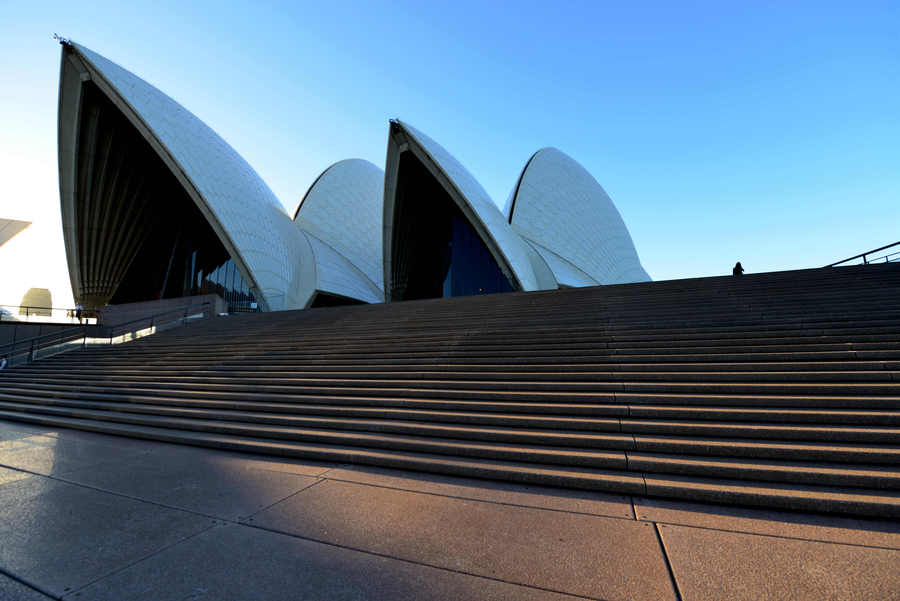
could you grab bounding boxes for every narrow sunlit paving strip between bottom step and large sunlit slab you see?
[325,466,634,519]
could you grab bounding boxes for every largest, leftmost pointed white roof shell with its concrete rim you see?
[59,43,310,310]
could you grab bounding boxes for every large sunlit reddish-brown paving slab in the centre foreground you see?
[248,480,675,601]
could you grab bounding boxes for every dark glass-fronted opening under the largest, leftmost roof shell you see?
[75,82,255,308]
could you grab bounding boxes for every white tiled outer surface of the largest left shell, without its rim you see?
[73,44,308,308]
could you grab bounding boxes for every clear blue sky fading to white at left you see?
[0,0,900,296]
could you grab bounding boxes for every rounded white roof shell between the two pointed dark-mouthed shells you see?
[294,159,384,302]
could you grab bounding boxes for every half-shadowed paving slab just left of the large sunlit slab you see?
[59,448,321,520]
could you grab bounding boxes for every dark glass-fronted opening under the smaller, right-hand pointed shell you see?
[390,151,514,301]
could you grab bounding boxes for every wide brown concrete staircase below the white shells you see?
[0,264,900,517]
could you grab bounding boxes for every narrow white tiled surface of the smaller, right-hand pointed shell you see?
[400,122,556,290]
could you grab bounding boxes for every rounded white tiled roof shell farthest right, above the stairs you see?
[506,148,650,286]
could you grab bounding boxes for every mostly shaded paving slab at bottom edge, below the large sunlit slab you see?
[64,524,575,601]
